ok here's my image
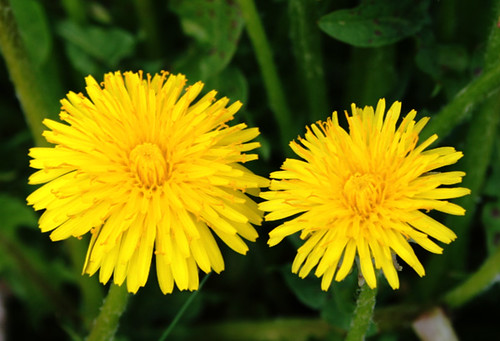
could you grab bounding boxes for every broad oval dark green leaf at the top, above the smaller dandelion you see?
[319,0,429,47]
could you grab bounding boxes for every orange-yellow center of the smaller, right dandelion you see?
[344,173,383,218]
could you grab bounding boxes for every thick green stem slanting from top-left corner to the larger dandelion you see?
[0,0,50,146]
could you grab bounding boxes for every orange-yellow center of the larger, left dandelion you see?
[129,143,168,188]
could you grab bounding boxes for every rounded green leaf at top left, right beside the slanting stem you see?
[10,0,52,66]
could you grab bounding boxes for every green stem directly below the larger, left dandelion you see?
[87,284,129,341]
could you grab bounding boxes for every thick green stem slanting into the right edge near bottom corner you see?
[444,245,500,308]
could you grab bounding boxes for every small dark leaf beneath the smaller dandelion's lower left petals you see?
[281,265,328,310]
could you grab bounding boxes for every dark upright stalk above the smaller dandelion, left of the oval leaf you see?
[288,0,330,122]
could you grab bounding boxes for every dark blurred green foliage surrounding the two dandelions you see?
[0,0,500,341]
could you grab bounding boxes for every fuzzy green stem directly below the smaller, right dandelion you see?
[346,283,377,341]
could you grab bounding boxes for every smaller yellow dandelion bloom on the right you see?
[260,100,470,290]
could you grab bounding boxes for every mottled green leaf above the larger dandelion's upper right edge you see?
[170,0,243,79]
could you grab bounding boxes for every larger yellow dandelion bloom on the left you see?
[27,72,268,293]
